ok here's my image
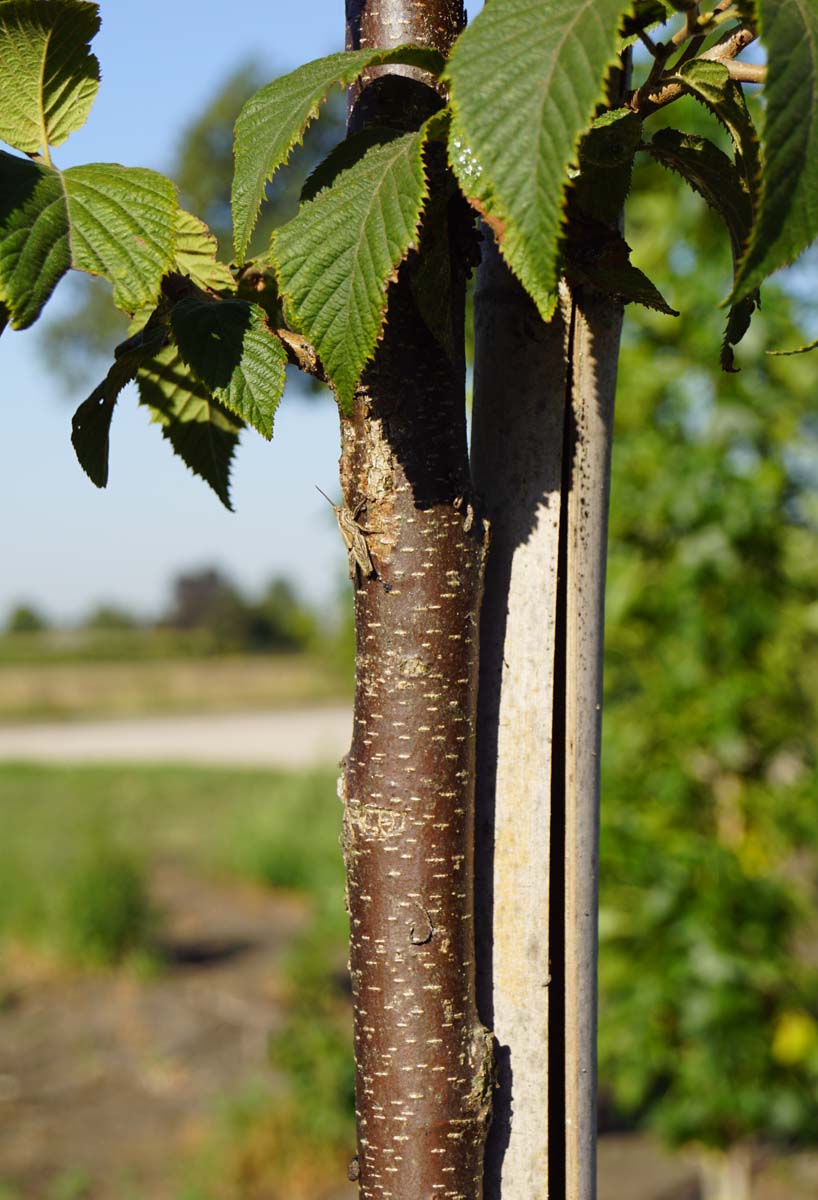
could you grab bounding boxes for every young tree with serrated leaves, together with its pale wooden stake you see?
[0,0,818,1200]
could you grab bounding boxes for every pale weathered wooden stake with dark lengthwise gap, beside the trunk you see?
[471,247,621,1200]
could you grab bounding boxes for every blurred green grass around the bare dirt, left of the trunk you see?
[0,766,353,1200]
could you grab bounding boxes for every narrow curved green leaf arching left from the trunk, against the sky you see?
[233,46,443,263]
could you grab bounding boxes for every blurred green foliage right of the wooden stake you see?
[592,93,818,1194]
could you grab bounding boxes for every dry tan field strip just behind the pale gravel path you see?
[0,654,351,720]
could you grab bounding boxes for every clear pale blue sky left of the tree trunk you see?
[0,7,480,624]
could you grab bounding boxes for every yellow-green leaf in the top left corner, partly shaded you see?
[0,0,100,158]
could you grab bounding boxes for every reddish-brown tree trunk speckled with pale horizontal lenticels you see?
[341,0,492,1200]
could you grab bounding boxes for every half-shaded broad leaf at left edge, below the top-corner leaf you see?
[0,154,178,329]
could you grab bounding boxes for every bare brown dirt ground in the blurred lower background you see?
[0,864,818,1200]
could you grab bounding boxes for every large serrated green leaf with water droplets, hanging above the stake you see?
[445,0,631,319]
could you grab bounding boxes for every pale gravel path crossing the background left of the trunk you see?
[0,704,351,767]
